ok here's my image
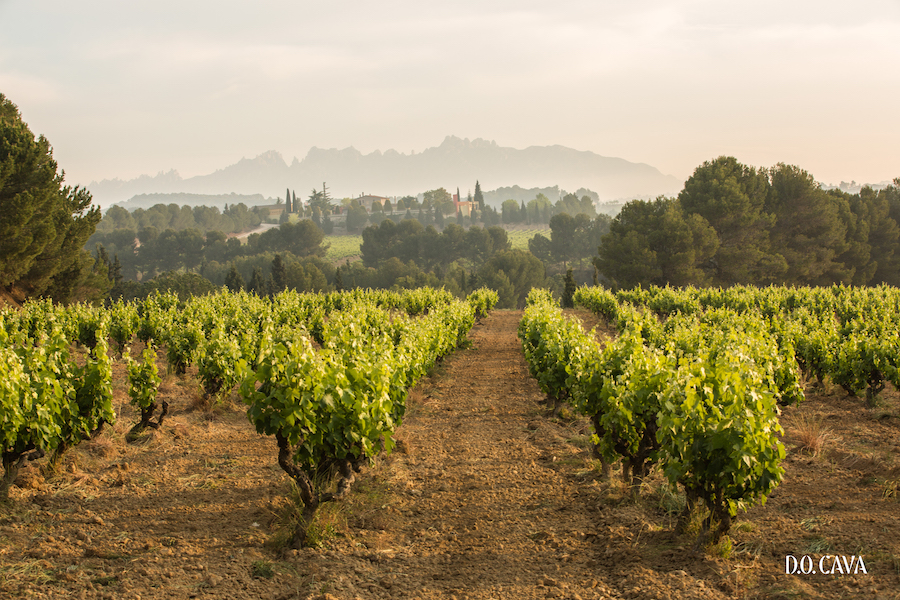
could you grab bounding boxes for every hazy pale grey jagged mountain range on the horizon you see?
[87,136,683,207]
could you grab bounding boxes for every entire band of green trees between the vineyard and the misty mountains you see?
[8,86,900,307]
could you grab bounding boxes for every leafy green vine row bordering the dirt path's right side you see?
[519,288,802,541]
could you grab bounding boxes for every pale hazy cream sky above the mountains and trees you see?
[0,0,900,185]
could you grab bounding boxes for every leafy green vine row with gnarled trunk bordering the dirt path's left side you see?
[241,290,475,543]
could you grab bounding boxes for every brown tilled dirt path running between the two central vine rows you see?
[310,311,606,598]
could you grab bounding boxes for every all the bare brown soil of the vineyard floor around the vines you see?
[0,311,900,600]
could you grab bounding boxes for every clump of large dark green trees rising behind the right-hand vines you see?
[594,156,900,288]
